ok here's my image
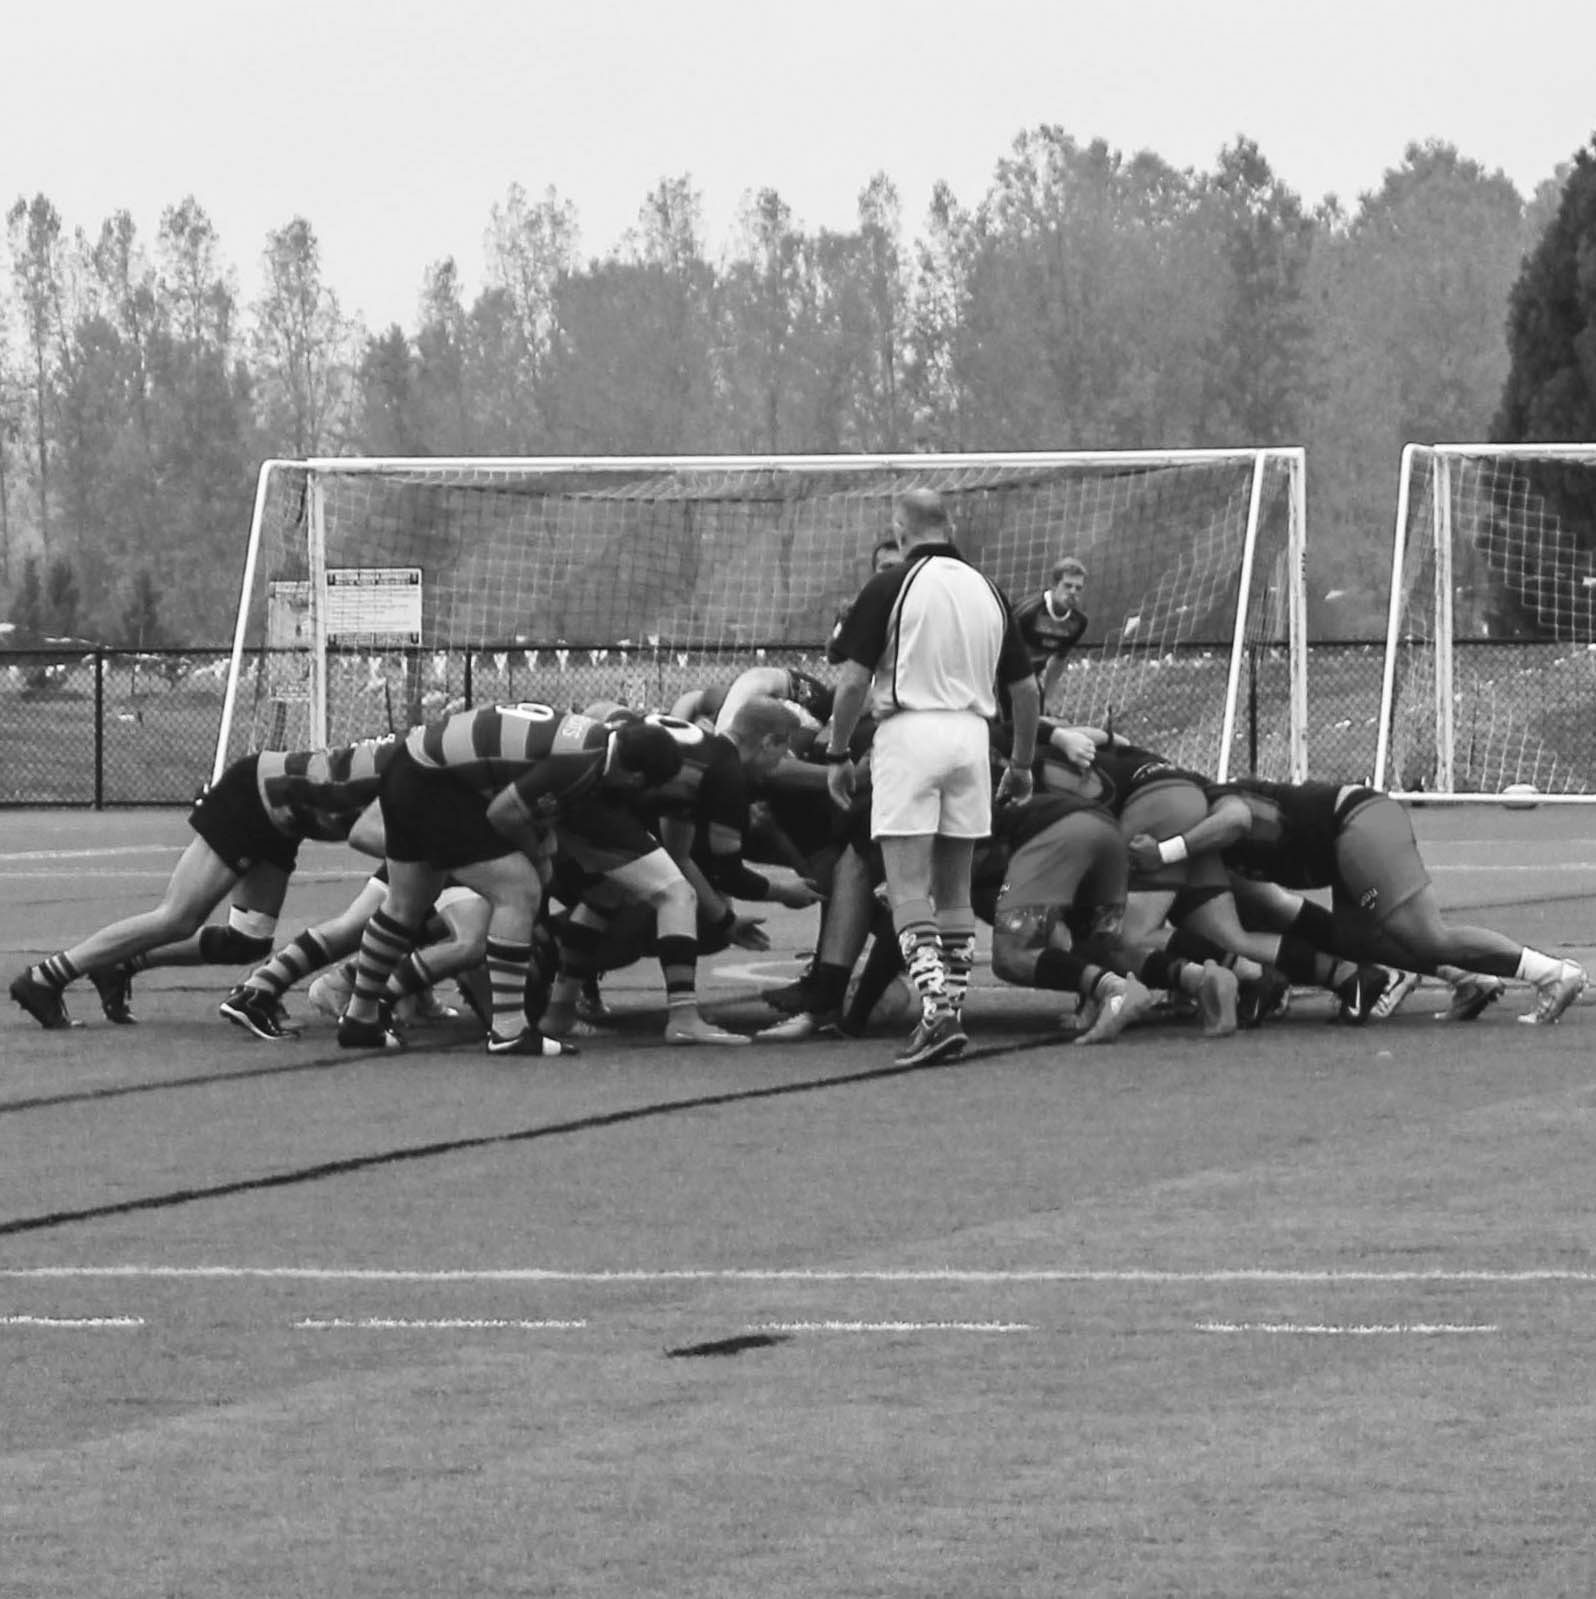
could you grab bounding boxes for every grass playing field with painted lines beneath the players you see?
[0,807,1596,1599]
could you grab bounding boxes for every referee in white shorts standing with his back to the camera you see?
[825,489,1039,1065]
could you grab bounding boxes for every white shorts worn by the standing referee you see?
[870,710,992,838]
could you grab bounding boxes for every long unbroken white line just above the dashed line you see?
[9,1263,1596,1287]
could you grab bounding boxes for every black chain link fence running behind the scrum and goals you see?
[0,643,1596,809]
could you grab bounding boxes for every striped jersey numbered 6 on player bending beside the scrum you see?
[405,704,611,819]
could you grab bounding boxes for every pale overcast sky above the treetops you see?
[0,0,1596,329]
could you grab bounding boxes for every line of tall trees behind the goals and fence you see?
[9,126,1596,648]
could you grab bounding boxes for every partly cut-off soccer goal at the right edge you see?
[1374,445,1596,804]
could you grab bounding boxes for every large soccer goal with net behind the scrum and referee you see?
[216,449,1307,777]
